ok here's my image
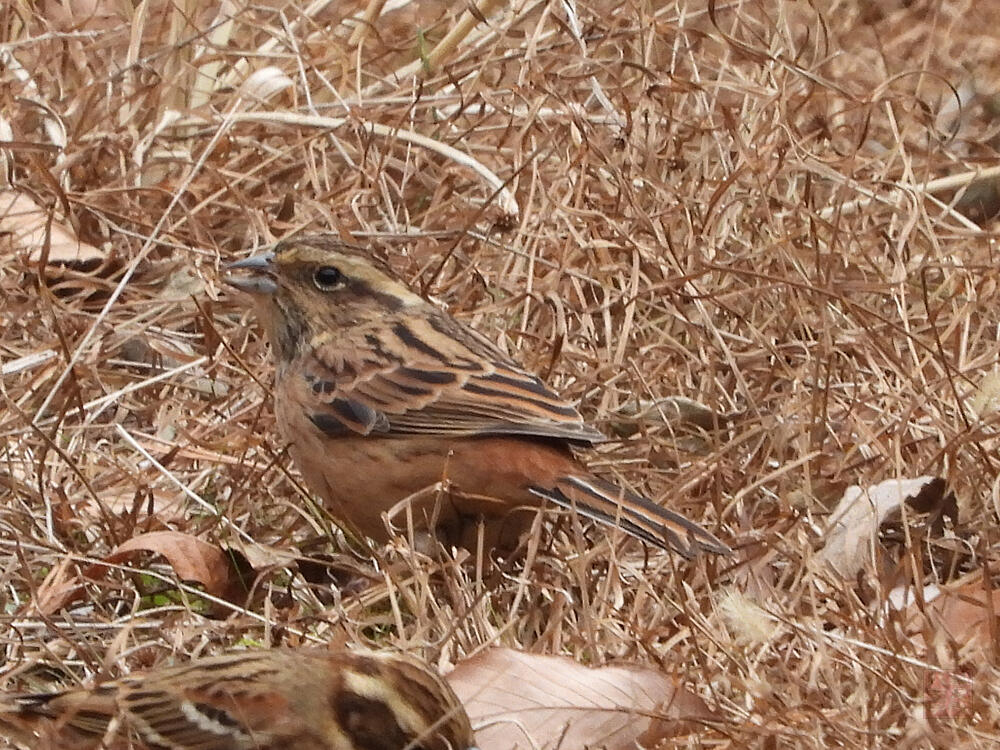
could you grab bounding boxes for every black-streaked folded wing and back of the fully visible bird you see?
[296,315,603,443]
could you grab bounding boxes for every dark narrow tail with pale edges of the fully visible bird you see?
[531,476,732,558]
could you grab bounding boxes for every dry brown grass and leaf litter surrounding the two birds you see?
[0,0,1000,748]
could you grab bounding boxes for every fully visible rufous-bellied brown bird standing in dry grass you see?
[227,235,730,557]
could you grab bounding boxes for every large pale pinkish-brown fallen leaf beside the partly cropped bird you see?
[447,648,719,750]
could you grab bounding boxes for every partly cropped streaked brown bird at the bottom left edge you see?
[0,649,474,750]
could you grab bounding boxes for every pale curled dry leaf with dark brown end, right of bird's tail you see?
[819,477,945,577]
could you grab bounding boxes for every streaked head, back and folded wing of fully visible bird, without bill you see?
[254,237,604,444]
